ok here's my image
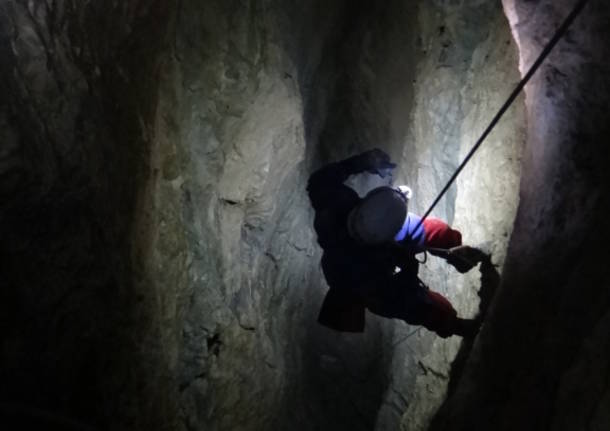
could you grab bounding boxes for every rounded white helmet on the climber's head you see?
[347,187,410,245]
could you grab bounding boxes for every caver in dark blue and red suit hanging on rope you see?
[307,149,488,338]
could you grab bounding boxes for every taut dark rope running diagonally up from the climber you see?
[414,0,588,232]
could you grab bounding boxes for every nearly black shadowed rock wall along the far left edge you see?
[0,1,175,429]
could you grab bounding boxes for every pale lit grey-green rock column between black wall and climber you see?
[167,1,341,429]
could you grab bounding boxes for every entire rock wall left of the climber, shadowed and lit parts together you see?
[1,1,390,430]
